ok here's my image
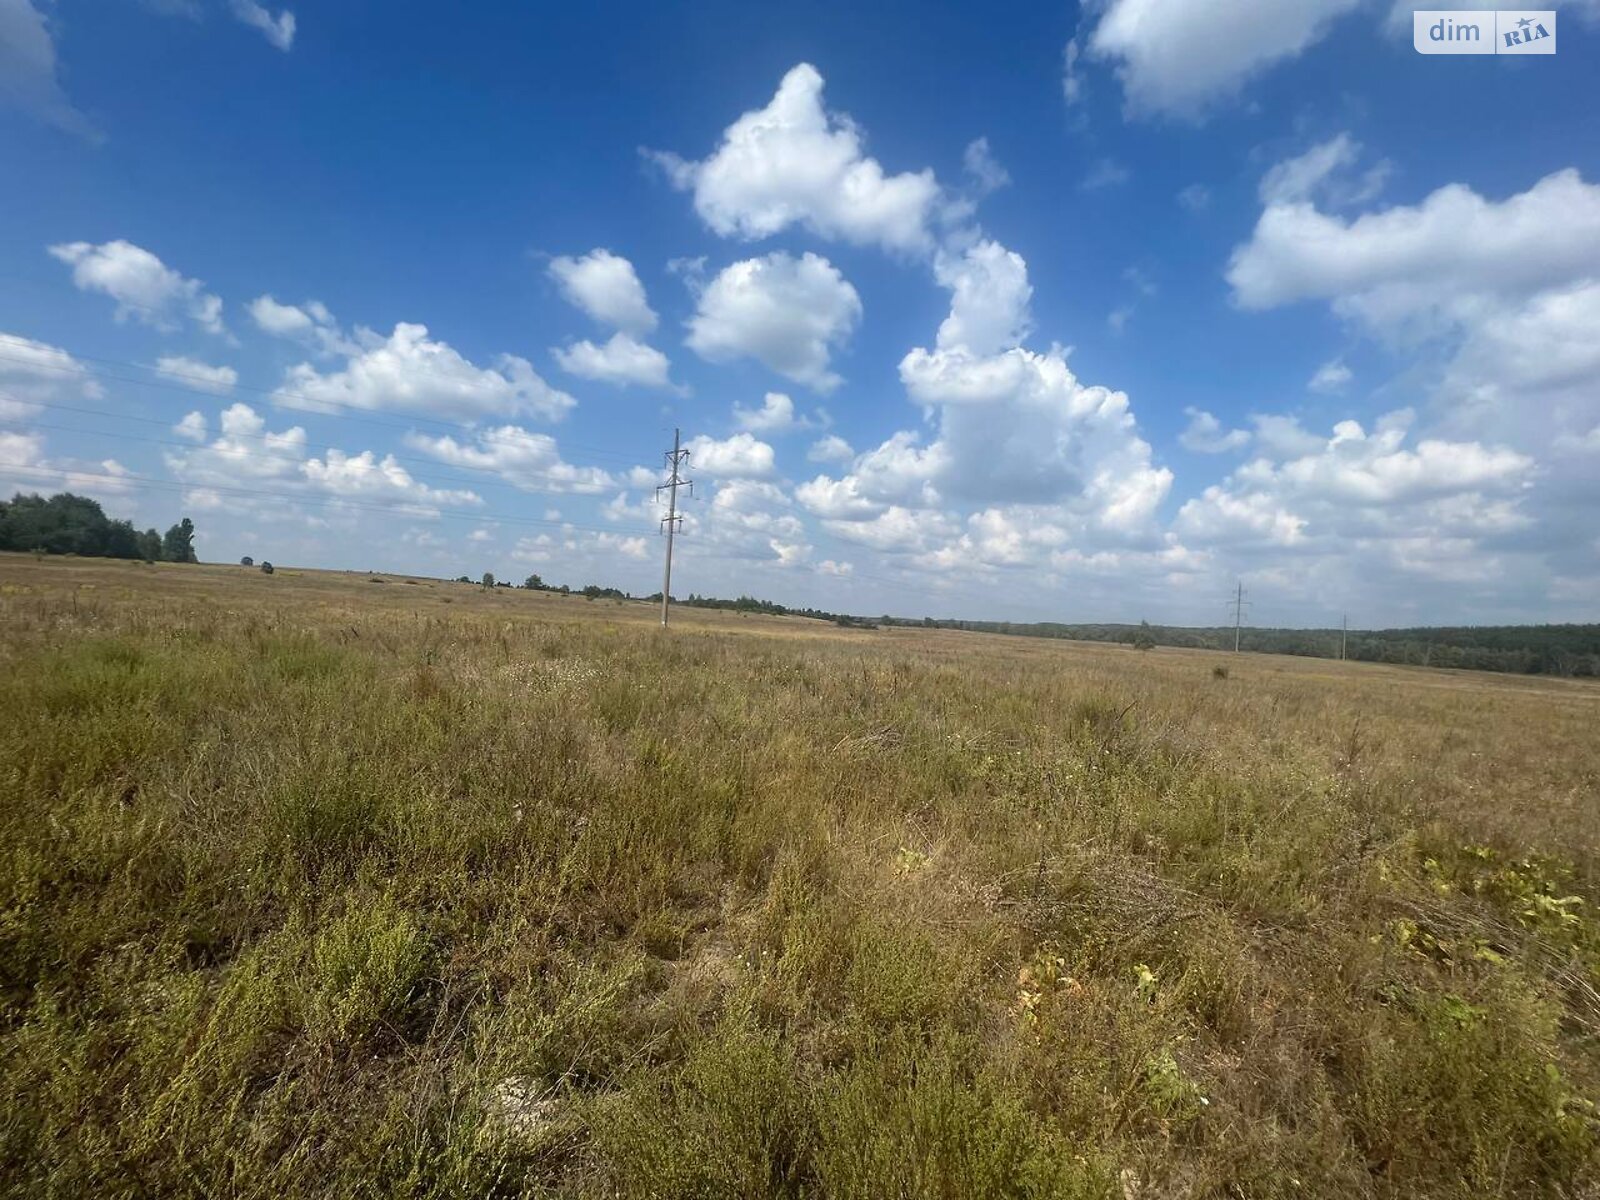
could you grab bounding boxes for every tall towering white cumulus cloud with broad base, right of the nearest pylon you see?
[795,242,1171,573]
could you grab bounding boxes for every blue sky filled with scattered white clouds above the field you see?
[0,0,1600,626]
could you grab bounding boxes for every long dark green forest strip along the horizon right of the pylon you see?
[658,595,1600,677]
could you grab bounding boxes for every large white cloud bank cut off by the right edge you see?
[1227,156,1600,492]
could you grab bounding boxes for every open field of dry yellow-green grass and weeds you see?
[0,555,1600,1200]
